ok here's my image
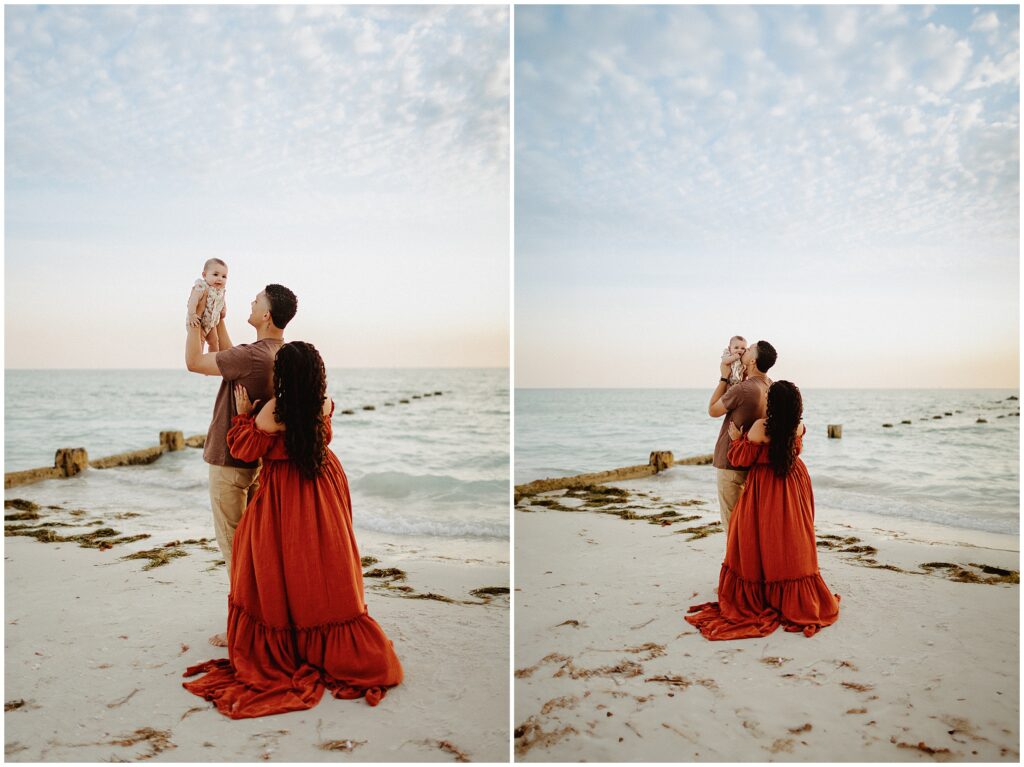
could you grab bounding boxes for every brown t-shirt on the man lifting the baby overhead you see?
[203,338,285,469]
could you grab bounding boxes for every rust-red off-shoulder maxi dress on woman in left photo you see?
[182,403,402,719]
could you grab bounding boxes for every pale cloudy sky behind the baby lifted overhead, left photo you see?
[4,5,510,368]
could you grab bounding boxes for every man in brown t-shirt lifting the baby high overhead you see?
[185,285,298,647]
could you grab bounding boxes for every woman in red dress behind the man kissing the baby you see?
[686,381,839,639]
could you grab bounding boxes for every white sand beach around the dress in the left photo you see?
[4,501,509,762]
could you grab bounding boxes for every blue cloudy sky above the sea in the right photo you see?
[514,5,1020,389]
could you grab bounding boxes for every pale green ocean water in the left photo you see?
[4,369,509,540]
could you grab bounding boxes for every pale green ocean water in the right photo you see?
[514,389,1020,535]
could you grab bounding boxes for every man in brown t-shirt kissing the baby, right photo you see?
[708,341,778,536]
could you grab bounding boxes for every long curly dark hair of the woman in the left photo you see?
[273,341,327,479]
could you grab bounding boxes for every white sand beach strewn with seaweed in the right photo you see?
[513,467,1020,762]
